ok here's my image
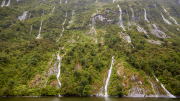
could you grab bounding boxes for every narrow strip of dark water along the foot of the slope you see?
[0,97,180,101]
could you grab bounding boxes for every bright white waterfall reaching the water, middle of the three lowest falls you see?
[105,56,114,97]
